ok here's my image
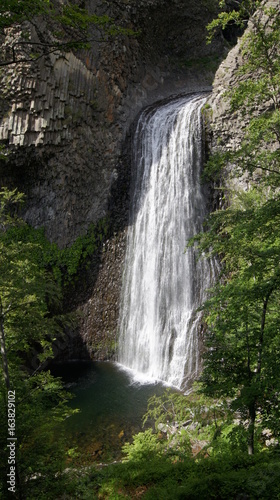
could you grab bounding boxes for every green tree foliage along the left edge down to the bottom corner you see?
[0,189,89,500]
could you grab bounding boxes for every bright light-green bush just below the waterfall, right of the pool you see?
[144,383,235,460]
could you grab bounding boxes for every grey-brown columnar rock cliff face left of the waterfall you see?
[0,0,224,357]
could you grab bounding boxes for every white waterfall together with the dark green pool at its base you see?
[50,94,215,463]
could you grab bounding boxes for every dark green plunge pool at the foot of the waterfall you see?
[51,361,175,465]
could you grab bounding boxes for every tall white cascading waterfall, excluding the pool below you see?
[118,95,211,388]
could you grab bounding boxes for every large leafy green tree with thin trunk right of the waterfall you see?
[190,188,280,448]
